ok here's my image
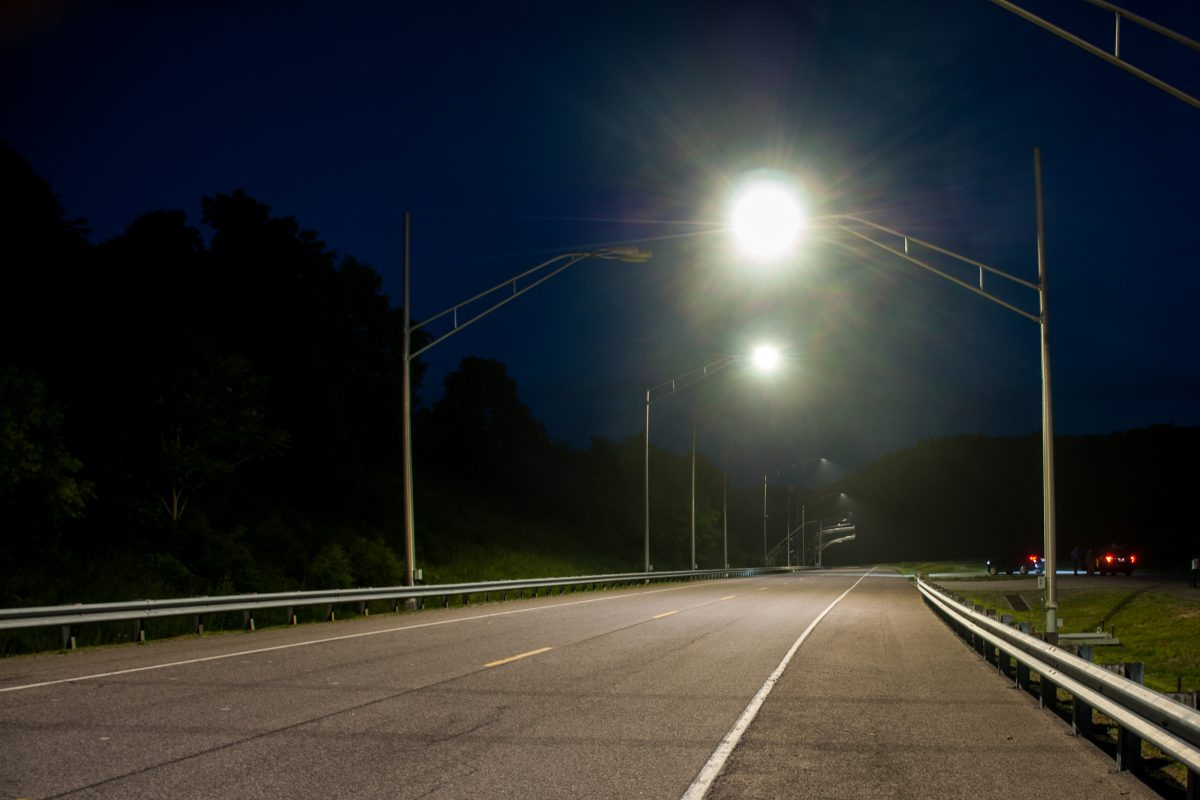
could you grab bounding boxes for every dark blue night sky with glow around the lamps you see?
[0,0,1200,480]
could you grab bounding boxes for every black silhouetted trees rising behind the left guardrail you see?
[0,146,739,606]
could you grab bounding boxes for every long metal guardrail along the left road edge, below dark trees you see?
[0,567,797,649]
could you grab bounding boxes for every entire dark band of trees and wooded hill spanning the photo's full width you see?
[0,145,1200,607]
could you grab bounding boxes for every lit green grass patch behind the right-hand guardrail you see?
[936,588,1200,692]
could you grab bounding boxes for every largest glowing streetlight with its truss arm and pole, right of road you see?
[730,148,1058,633]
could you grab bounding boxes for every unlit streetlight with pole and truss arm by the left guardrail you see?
[401,213,650,607]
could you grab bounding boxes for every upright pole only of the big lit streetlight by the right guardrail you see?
[1033,148,1058,633]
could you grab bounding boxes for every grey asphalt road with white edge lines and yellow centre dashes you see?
[0,571,1154,800]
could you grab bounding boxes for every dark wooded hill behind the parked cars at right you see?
[827,426,1200,569]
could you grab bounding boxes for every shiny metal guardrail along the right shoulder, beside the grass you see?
[917,577,1200,799]
